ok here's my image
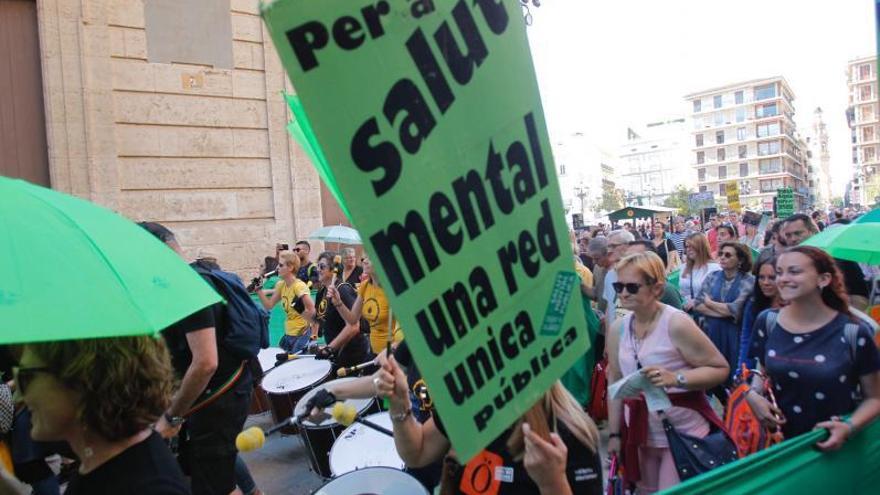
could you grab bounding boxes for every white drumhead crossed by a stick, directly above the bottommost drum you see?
[330,412,404,476]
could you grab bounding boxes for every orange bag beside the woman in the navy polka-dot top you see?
[724,365,782,458]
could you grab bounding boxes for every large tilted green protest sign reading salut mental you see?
[263,0,589,459]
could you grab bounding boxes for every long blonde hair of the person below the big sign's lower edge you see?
[507,380,599,461]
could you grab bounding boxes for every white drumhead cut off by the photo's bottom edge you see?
[312,467,429,495]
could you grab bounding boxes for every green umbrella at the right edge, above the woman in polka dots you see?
[801,220,880,265]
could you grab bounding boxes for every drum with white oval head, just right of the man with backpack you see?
[262,358,332,435]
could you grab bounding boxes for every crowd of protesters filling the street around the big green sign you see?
[0,206,880,495]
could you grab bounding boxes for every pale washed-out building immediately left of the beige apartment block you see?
[618,117,696,205]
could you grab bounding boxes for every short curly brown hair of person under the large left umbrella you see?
[26,336,173,441]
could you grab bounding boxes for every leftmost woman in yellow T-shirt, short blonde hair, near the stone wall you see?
[257,251,315,353]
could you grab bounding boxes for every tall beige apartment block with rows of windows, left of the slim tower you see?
[685,76,809,210]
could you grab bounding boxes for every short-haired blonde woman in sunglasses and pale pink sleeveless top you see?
[606,253,729,493]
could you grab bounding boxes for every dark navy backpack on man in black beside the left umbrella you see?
[196,265,269,360]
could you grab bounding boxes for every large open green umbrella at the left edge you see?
[0,176,221,344]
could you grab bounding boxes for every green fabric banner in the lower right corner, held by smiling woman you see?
[662,421,880,495]
